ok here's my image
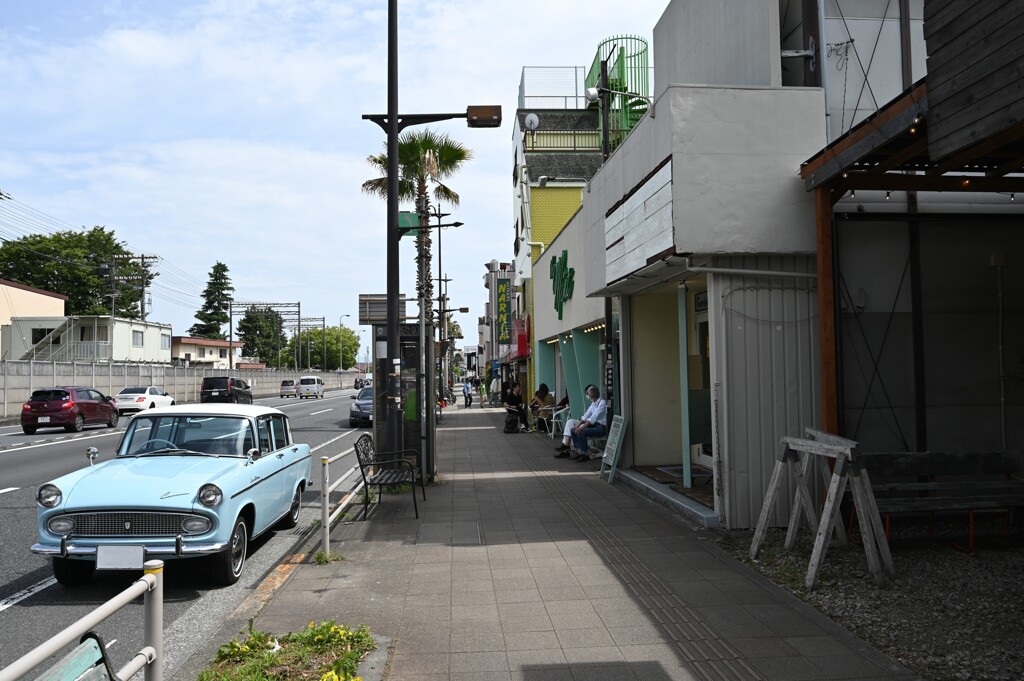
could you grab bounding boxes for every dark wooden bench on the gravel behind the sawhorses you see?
[859,452,1024,552]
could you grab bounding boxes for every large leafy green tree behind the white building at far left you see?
[0,226,151,320]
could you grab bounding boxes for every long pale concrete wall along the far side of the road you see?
[0,359,355,419]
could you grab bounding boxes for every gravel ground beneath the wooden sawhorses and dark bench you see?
[719,515,1024,681]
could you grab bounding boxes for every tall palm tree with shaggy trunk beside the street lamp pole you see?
[362,129,473,301]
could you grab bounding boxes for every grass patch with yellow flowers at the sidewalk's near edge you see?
[197,620,377,681]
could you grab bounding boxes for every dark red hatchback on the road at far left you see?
[22,386,119,435]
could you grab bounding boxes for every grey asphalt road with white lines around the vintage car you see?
[0,390,369,678]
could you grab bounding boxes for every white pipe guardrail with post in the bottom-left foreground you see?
[0,560,164,681]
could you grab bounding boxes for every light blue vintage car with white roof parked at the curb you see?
[32,403,312,586]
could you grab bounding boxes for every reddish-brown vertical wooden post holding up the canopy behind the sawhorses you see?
[814,186,842,433]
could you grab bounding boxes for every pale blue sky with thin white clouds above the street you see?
[0,0,668,359]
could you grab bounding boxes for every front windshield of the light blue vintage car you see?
[118,415,256,457]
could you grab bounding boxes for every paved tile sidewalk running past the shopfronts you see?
[249,406,915,681]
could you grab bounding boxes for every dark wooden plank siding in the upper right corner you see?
[925,0,1024,160]
